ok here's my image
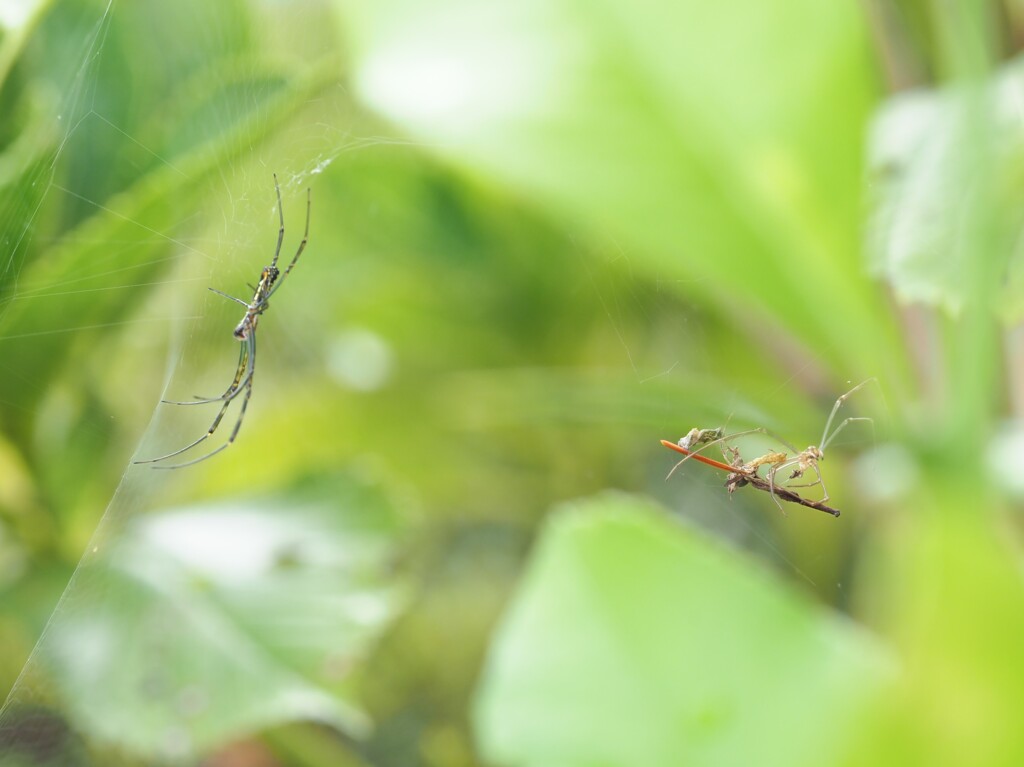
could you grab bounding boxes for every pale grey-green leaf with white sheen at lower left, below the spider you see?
[18,477,404,759]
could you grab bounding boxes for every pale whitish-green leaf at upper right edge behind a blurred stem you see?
[868,53,1024,322]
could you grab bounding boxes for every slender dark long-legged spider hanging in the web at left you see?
[135,173,310,469]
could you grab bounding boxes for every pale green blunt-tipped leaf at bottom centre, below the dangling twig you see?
[476,495,888,767]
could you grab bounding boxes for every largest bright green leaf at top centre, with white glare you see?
[341,0,888,370]
